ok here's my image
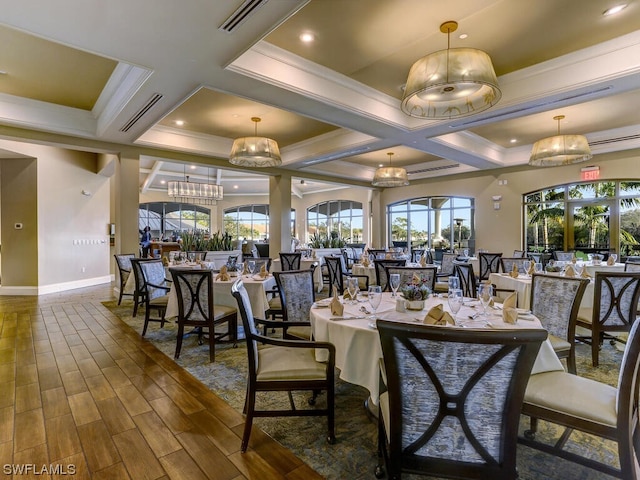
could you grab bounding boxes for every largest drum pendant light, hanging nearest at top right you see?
[402,20,502,119]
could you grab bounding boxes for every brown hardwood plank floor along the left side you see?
[0,285,321,480]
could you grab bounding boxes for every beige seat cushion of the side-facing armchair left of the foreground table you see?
[257,347,327,381]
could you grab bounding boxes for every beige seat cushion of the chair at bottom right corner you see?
[524,371,618,427]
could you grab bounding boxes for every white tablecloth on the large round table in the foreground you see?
[310,293,563,405]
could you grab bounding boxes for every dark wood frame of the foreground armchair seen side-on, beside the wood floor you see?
[231,279,336,453]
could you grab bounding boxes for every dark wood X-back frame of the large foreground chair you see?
[375,320,547,479]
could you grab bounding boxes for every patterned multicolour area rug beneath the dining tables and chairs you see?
[103,301,622,480]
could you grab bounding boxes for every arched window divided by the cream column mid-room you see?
[224,205,296,242]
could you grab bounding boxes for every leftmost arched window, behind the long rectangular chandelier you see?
[138,202,211,238]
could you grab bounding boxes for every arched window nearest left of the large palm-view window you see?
[387,197,475,252]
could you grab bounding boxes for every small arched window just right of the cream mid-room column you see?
[306,200,364,243]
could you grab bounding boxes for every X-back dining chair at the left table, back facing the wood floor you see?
[169,268,238,362]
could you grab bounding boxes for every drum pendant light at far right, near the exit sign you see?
[529,115,593,167]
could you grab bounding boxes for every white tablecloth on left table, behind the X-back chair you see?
[165,273,276,318]
